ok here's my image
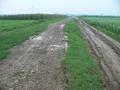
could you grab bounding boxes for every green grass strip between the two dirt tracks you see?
[64,21,102,90]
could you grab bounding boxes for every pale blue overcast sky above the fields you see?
[0,0,120,15]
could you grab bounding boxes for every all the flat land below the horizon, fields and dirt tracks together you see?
[0,16,120,90]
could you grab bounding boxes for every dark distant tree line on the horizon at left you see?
[0,14,66,20]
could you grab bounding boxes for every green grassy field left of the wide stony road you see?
[0,19,60,60]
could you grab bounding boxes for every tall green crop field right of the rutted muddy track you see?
[82,17,120,42]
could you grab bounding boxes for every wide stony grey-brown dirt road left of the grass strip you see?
[0,22,67,90]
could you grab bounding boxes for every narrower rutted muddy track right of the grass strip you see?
[80,22,120,90]
